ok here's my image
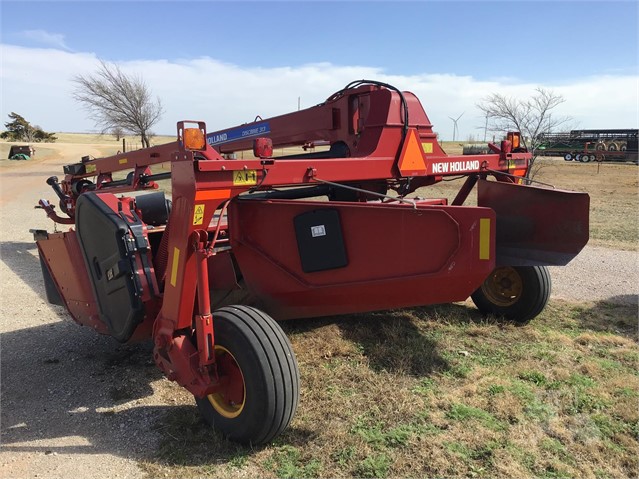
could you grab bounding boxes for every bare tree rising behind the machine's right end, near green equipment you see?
[477,88,571,178]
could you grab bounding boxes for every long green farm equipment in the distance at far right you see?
[537,129,639,163]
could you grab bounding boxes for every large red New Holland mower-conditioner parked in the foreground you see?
[33,80,589,444]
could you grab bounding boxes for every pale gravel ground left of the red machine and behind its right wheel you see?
[0,144,639,479]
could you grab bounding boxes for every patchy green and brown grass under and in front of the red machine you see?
[142,302,639,478]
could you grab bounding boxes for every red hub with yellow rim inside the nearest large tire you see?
[208,345,246,419]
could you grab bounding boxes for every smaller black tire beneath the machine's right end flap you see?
[471,266,552,325]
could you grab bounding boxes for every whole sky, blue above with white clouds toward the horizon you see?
[0,1,639,139]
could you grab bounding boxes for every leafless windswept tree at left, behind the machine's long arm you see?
[73,61,163,148]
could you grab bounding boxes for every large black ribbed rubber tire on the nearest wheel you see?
[195,306,300,445]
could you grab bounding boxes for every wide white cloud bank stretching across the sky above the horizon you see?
[0,45,639,139]
